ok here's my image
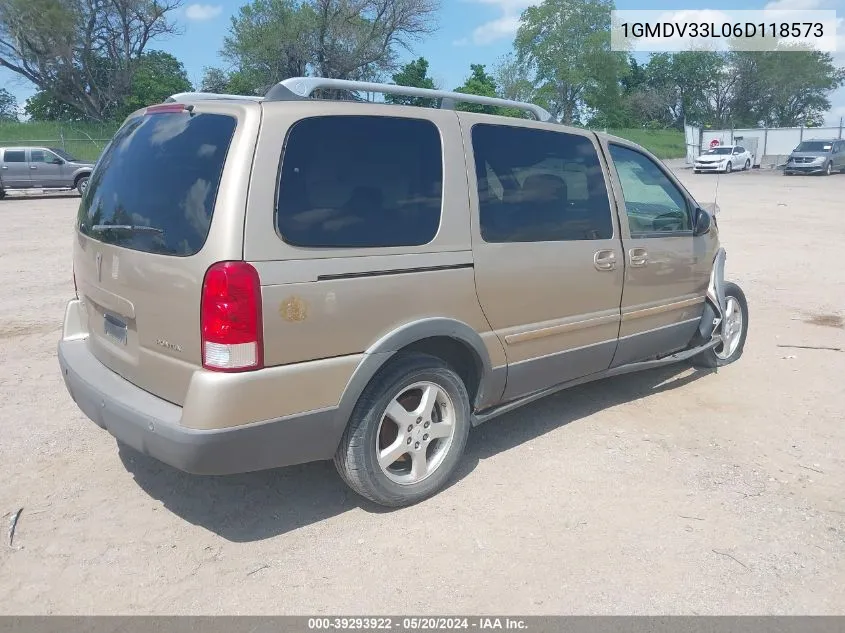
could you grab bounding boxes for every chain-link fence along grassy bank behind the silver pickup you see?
[0,121,120,161]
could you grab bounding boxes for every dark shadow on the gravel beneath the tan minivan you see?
[119,363,712,542]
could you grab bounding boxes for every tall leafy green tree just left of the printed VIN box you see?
[514,0,627,124]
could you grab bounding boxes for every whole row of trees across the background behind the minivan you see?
[0,0,845,128]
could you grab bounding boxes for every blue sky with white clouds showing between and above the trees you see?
[0,0,845,124]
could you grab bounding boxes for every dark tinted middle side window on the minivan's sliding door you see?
[472,124,613,242]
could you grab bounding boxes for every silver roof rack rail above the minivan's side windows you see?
[264,77,554,122]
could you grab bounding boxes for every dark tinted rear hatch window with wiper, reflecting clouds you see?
[79,112,237,256]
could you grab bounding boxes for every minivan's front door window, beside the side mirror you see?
[610,145,692,237]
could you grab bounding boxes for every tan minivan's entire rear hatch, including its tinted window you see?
[74,103,260,405]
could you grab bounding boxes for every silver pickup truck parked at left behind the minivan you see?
[0,147,94,198]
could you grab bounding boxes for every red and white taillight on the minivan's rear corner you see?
[200,262,264,371]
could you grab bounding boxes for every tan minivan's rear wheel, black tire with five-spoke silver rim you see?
[334,353,471,508]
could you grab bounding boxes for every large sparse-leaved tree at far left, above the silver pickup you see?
[0,0,182,120]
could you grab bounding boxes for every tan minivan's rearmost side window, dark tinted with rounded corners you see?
[276,116,443,248]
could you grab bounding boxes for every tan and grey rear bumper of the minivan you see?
[58,338,343,475]
